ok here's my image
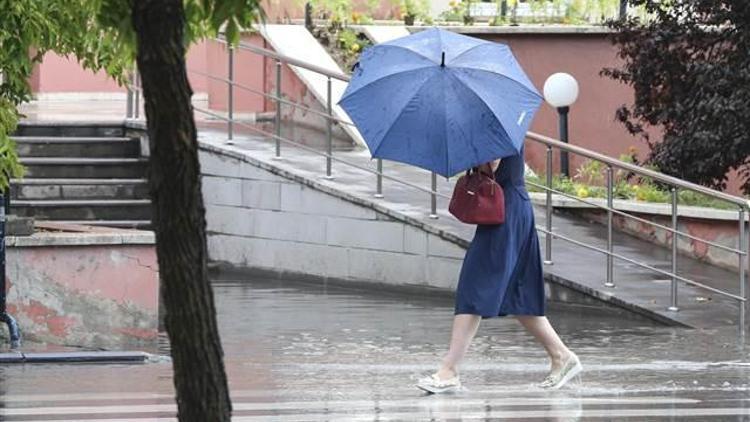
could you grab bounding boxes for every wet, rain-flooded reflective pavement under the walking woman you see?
[0,274,750,422]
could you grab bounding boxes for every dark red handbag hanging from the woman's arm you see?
[448,165,505,224]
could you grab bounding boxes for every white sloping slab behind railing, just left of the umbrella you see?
[258,25,365,146]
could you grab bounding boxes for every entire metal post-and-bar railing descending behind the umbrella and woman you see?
[126,33,750,338]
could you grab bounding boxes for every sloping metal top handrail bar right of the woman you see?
[526,132,750,208]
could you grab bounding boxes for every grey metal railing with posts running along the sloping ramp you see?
[128,34,750,335]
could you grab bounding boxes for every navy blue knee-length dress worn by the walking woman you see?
[454,150,545,318]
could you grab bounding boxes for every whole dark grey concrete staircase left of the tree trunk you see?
[11,123,151,228]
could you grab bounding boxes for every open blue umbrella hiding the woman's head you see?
[339,28,542,177]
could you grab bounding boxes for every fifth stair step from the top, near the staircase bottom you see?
[10,199,151,221]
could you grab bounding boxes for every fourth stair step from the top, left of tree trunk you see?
[10,179,149,202]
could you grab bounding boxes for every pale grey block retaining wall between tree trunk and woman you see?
[201,151,465,289]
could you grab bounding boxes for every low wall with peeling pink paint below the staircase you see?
[6,231,159,349]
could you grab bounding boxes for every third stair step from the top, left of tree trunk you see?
[21,157,148,179]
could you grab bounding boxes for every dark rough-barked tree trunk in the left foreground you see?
[132,0,232,422]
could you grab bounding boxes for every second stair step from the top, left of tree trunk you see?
[13,136,141,158]
